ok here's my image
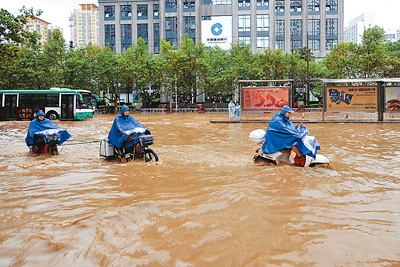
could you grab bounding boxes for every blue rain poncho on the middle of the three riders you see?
[107,105,150,148]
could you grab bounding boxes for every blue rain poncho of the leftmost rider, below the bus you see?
[25,110,71,149]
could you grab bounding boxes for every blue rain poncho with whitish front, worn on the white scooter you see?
[262,105,320,158]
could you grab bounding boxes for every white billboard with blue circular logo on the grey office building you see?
[201,16,232,50]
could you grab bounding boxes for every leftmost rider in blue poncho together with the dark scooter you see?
[25,110,71,155]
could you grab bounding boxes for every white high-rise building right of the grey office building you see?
[344,13,375,44]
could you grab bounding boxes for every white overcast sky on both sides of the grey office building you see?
[0,0,400,42]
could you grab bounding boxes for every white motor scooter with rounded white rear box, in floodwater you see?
[249,127,329,167]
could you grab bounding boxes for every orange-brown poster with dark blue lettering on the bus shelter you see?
[325,86,378,111]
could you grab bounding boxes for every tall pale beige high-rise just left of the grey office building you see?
[69,4,99,47]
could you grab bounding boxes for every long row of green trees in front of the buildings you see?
[0,8,400,107]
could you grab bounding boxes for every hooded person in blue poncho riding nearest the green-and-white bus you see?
[25,110,71,149]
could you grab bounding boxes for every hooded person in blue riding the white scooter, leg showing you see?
[262,105,307,158]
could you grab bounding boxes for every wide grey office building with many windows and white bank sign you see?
[99,0,344,57]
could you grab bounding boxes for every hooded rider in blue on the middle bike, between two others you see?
[108,105,150,148]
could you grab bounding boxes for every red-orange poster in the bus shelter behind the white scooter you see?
[243,87,289,110]
